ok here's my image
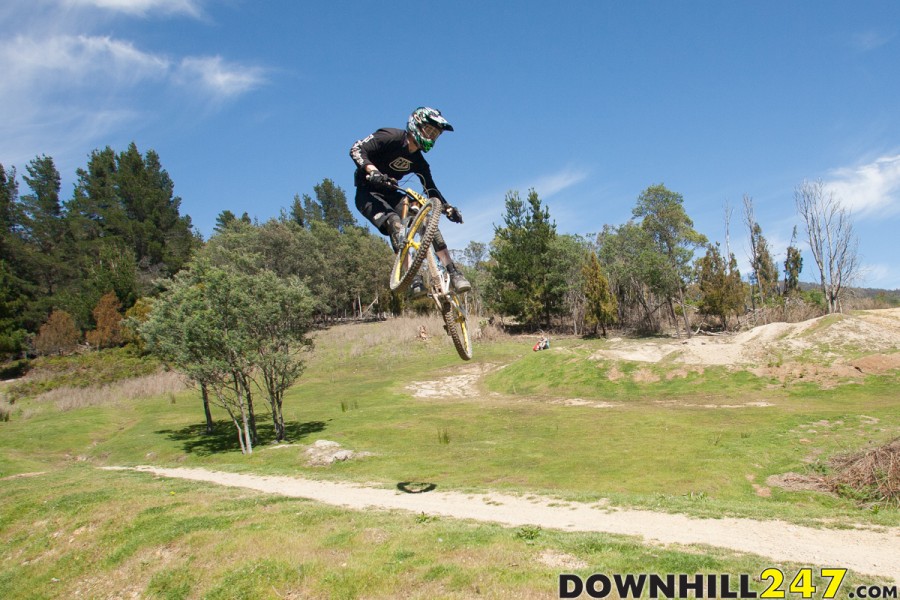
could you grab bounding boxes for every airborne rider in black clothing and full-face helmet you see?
[350,106,472,296]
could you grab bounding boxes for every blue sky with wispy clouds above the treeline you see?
[0,0,900,289]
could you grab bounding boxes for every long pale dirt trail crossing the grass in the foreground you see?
[109,466,900,582]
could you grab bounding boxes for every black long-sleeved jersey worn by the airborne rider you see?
[350,127,444,200]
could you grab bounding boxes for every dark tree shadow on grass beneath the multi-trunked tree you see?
[154,421,326,456]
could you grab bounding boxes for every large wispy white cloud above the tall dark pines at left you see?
[0,30,264,167]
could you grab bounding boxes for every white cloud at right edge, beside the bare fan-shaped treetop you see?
[825,154,900,217]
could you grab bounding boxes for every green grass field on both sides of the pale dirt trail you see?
[0,320,900,598]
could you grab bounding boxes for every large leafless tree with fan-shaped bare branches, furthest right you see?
[794,180,860,314]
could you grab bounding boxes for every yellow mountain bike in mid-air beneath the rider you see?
[391,186,472,360]
